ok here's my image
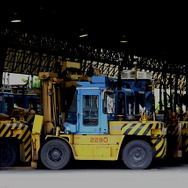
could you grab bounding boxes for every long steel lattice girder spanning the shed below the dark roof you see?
[0,29,186,92]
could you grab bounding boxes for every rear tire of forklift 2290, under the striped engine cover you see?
[122,140,154,169]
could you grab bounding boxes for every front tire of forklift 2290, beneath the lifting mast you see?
[40,139,72,170]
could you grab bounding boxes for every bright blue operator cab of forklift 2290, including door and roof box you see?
[64,76,115,134]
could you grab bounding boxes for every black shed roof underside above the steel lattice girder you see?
[0,0,188,75]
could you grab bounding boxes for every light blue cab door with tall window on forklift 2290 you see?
[78,89,101,134]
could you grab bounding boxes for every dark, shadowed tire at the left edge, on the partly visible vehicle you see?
[0,141,19,167]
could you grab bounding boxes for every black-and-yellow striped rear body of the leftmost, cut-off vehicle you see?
[0,123,31,162]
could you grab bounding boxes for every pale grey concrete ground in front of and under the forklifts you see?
[0,161,188,188]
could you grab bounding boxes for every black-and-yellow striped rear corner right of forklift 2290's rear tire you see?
[151,138,167,158]
